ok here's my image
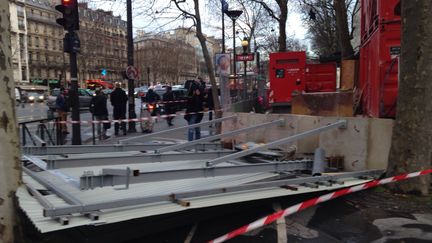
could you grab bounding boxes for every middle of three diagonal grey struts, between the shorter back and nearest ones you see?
[155,119,285,153]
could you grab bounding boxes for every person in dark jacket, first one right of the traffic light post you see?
[90,89,111,140]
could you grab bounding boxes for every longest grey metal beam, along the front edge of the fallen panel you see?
[44,170,383,217]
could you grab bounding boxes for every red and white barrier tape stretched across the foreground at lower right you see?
[209,169,432,243]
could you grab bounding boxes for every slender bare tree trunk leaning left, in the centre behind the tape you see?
[194,0,222,125]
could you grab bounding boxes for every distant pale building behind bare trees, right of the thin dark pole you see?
[134,28,221,84]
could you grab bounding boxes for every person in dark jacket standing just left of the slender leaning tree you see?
[184,86,203,141]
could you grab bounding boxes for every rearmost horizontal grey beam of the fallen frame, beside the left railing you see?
[22,142,222,155]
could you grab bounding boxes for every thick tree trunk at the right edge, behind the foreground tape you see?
[387,0,432,195]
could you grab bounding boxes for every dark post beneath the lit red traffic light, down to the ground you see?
[66,30,81,145]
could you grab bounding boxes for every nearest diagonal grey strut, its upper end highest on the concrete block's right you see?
[206,120,347,166]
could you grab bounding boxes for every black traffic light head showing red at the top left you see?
[55,0,79,31]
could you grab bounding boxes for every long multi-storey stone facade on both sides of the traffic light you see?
[10,0,127,87]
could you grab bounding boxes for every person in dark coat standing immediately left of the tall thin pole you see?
[110,82,128,136]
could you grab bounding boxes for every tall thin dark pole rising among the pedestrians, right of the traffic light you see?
[126,0,136,132]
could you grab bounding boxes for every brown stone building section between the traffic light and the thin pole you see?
[77,3,127,82]
